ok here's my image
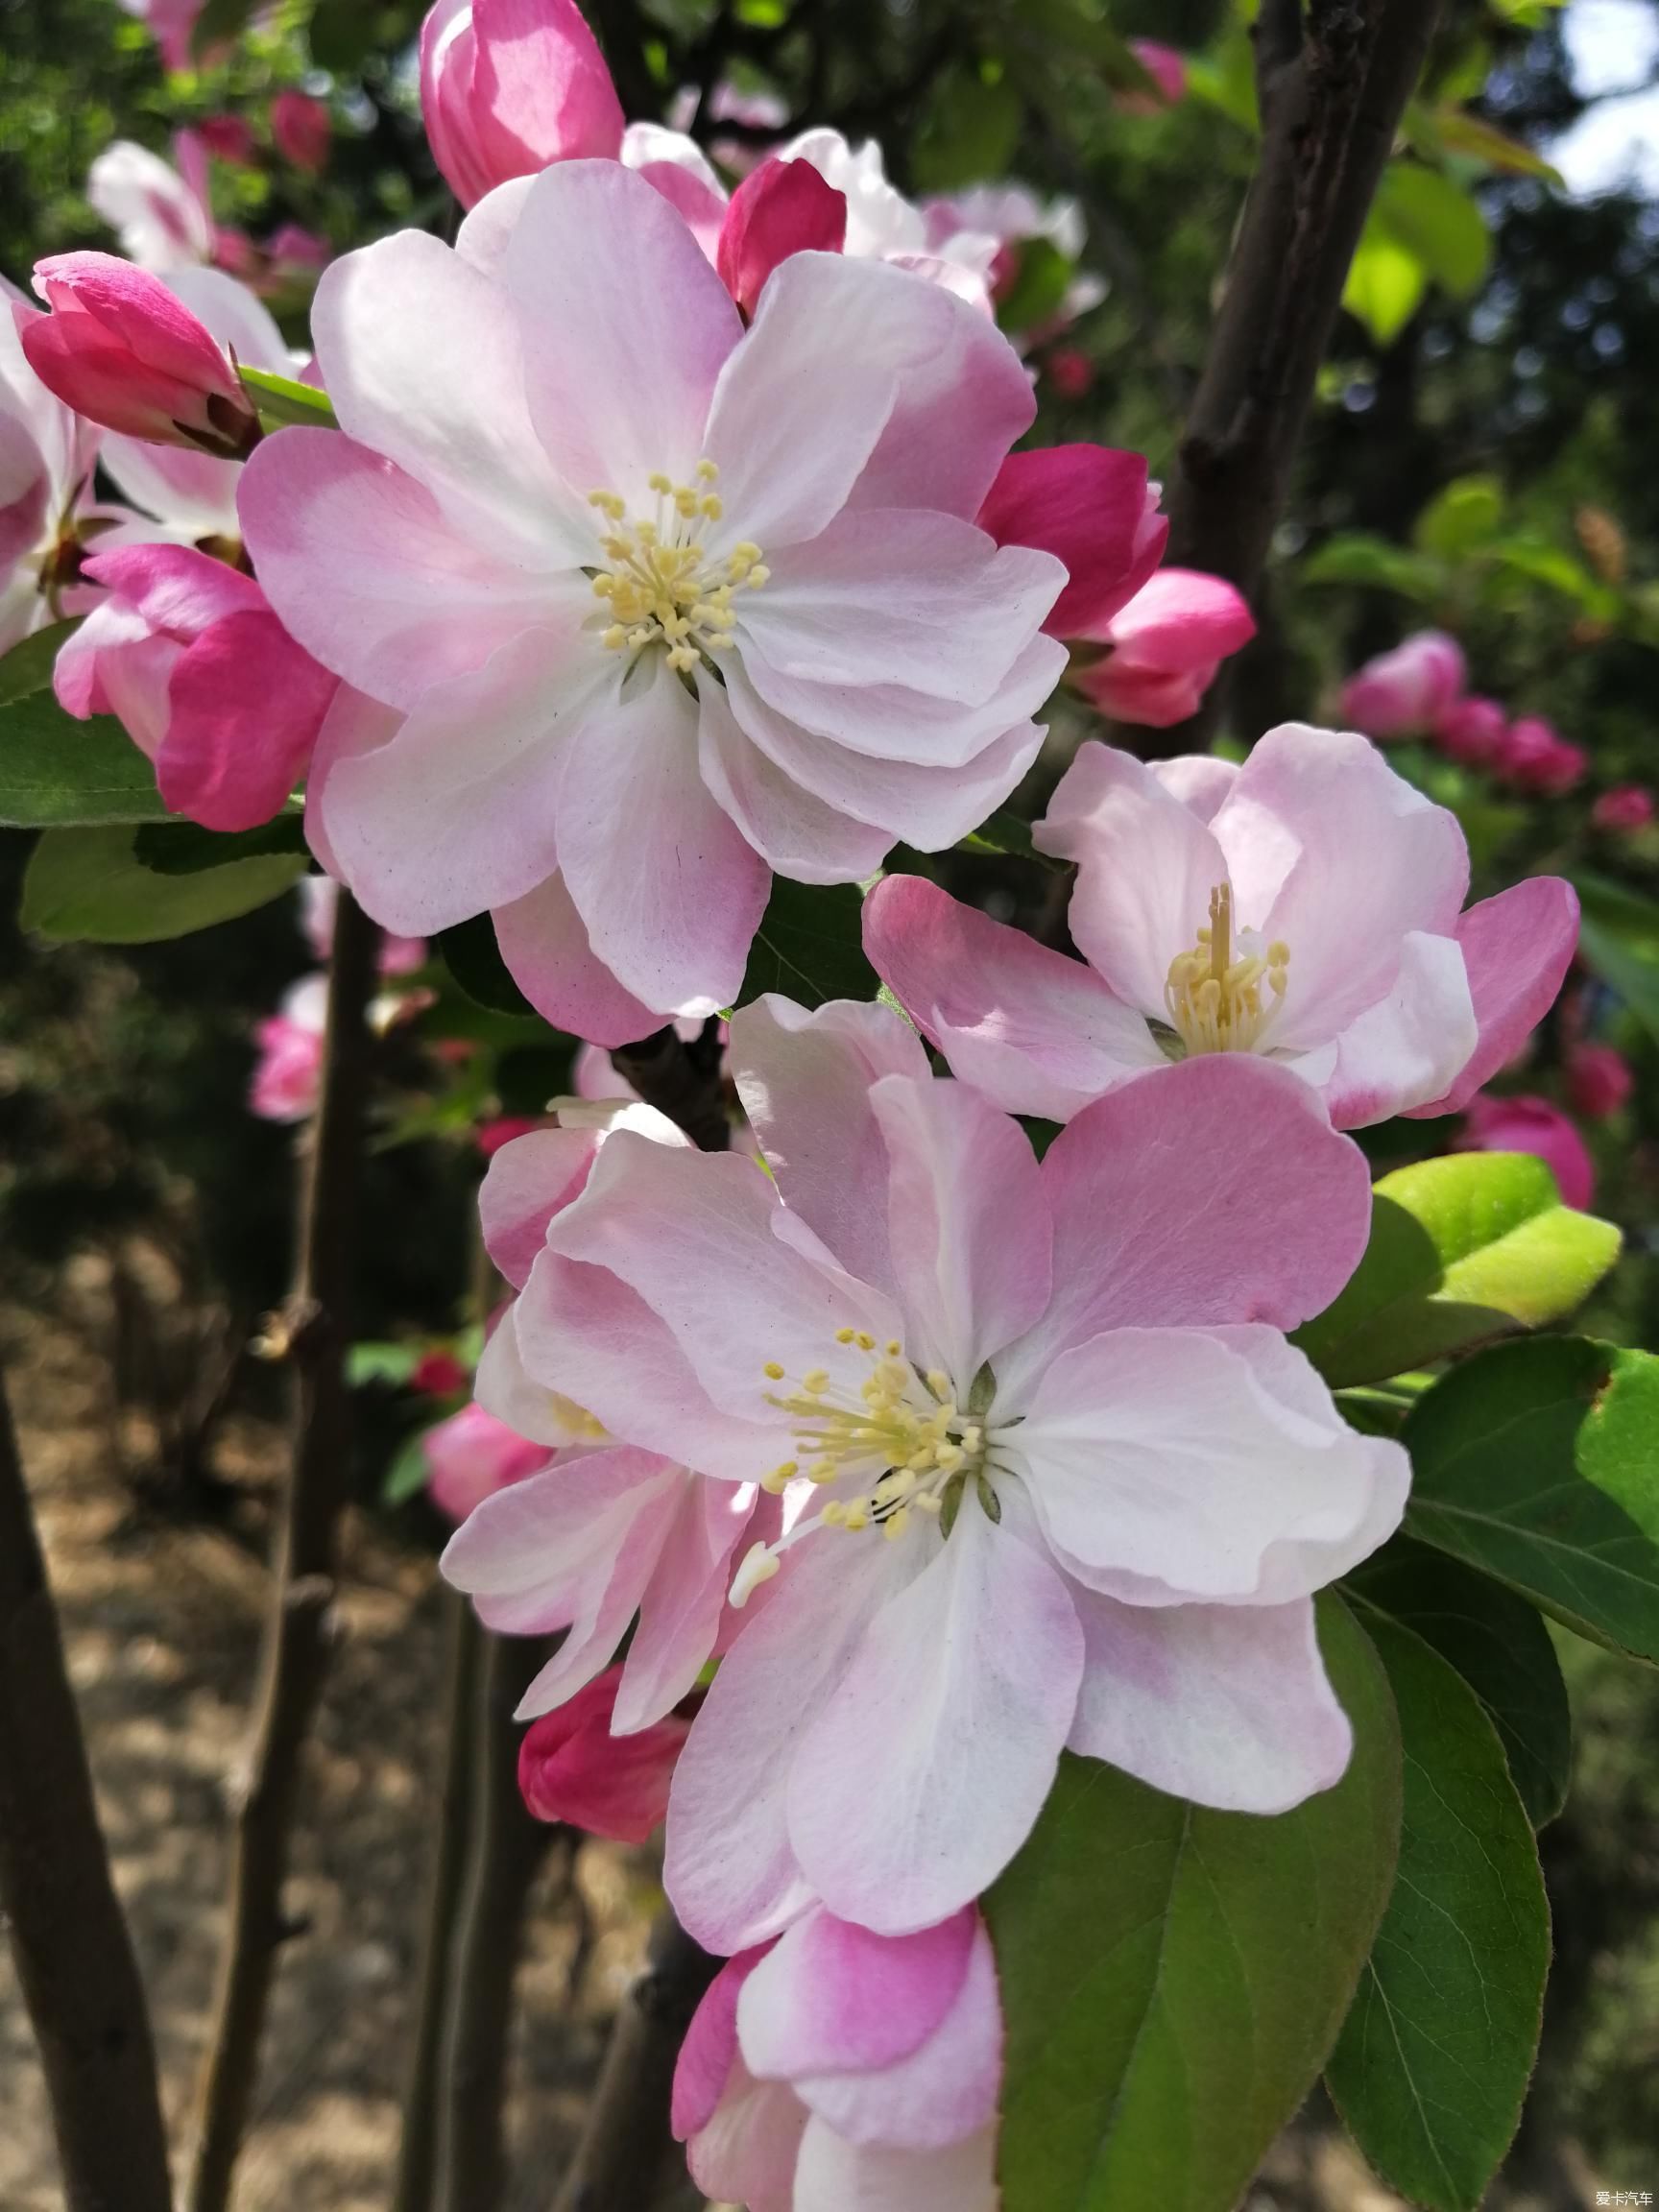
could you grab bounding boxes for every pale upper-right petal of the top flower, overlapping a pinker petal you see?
[706,254,898,553]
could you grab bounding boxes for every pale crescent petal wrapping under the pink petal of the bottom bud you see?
[791,1913,1002,2152]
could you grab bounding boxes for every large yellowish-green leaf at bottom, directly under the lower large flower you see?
[984,1597,1400,2212]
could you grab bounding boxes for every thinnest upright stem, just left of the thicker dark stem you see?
[392,1586,482,2212]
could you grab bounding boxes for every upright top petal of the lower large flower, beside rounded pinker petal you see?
[869,1075,1053,1403]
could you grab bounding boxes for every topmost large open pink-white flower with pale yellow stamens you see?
[239,161,1067,1044]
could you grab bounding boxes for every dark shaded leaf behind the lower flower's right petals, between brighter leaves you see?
[1343,1537,1573,1827]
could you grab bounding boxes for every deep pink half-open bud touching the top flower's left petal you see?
[53,544,336,830]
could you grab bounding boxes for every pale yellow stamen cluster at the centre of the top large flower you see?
[589,460,770,672]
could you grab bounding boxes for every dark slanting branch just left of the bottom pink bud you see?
[553,1913,721,2212]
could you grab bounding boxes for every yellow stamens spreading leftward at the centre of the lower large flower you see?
[733,1330,989,1606]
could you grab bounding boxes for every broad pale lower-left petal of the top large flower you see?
[323,631,615,936]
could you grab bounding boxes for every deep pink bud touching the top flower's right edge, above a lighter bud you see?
[977,445,1170,637]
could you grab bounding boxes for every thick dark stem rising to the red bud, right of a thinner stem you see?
[434,1637,555,2212]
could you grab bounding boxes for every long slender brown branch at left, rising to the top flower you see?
[186,892,380,2212]
